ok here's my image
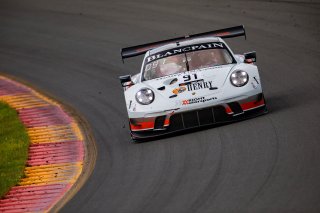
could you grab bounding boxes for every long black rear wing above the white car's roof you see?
[121,25,246,61]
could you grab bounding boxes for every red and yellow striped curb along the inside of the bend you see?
[0,76,84,213]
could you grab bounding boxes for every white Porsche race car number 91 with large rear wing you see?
[120,26,267,140]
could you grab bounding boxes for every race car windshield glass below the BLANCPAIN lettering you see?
[143,43,233,80]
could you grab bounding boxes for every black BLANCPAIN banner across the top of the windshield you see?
[146,42,225,63]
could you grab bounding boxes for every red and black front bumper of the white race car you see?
[129,93,267,140]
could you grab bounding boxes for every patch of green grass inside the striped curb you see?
[0,101,29,197]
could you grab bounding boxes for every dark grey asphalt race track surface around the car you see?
[0,0,320,213]
